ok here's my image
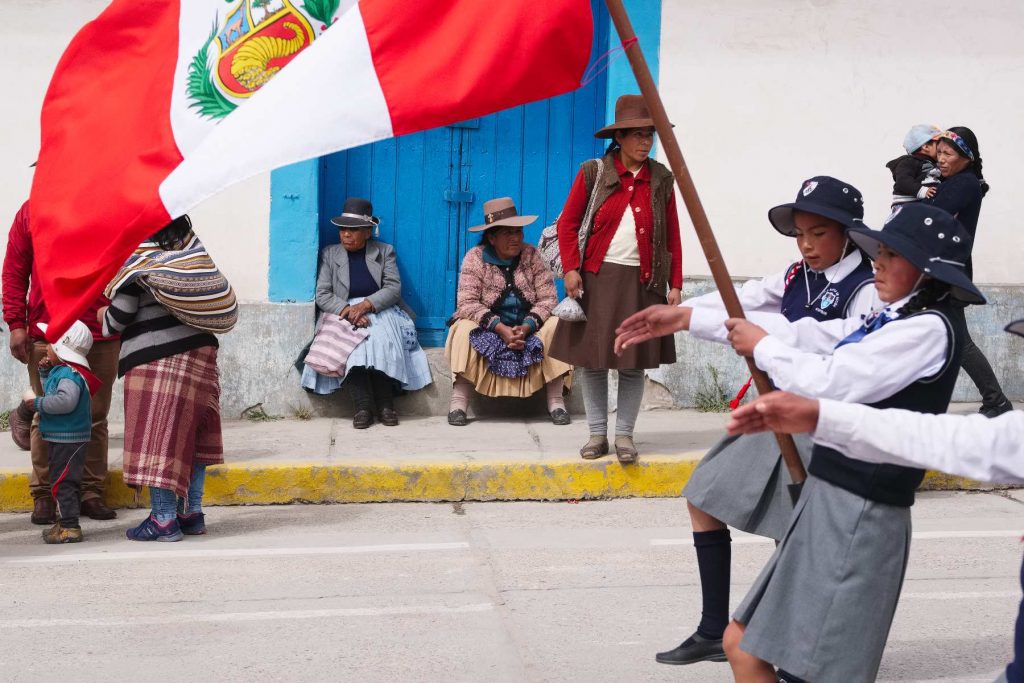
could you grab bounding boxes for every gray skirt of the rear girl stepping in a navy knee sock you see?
[683,433,812,541]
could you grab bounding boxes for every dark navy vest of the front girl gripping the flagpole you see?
[808,301,967,508]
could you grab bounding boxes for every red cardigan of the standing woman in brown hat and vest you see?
[558,155,683,290]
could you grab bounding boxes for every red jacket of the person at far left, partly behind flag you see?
[2,202,117,341]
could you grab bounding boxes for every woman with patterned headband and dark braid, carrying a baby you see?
[927,126,1014,418]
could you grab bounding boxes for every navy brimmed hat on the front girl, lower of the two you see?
[848,204,986,304]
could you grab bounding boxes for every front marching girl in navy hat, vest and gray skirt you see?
[704,204,985,682]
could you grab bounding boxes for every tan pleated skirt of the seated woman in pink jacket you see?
[444,315,572,398]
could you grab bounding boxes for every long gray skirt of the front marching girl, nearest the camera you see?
[733,476,910,683]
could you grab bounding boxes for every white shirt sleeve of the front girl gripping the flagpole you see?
[754,314,948,403]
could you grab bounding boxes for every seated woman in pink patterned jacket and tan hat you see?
[444,197,572,427]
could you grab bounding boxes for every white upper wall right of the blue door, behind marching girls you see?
[659,0,1024,284]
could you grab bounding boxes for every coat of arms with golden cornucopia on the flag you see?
[187,0,341,119]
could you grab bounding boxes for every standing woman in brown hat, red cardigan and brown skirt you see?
[551,95,683,463]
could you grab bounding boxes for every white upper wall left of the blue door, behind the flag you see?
[0,0,270,301]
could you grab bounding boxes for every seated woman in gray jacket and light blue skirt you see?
[302,198,431,429]
